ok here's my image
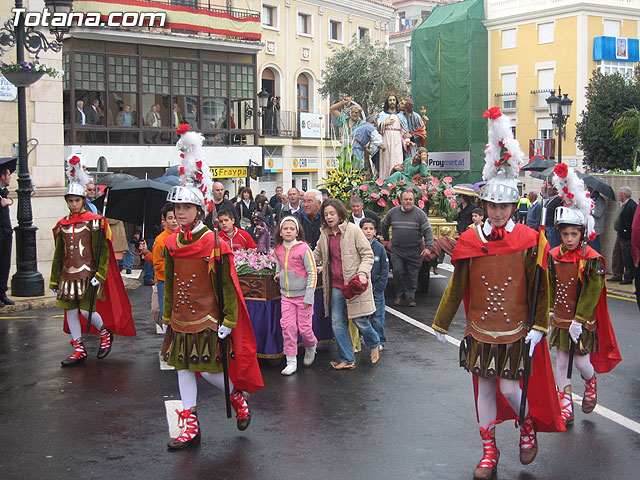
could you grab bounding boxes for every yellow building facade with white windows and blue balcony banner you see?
[485,0,640,167]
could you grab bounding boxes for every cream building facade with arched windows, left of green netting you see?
[255,0,393,194]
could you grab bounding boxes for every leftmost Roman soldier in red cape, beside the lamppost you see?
[49,155,136,367]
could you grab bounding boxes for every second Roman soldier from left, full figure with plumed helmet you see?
[162,125,263,449]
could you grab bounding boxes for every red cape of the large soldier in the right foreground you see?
[462,227,566,432]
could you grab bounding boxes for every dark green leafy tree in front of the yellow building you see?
[576,70,640,170]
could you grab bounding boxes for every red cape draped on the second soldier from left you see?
[165,232,264,393]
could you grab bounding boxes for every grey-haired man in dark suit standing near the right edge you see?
[608,186,638,285]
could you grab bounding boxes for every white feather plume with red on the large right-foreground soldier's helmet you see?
[482,109,525,180]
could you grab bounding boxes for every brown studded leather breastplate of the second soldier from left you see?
[171,257,220,333]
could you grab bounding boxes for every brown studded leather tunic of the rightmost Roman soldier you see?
[551,262,597,331]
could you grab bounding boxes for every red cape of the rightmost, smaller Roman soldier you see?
[550,245,622,373]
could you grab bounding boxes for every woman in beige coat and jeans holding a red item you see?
[313,198,380,370]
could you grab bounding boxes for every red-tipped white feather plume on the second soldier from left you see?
[176,131,213,209]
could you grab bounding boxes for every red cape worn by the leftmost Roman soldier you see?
[58,211,136,337]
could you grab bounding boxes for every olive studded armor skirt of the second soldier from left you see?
[161,325,222,373]
